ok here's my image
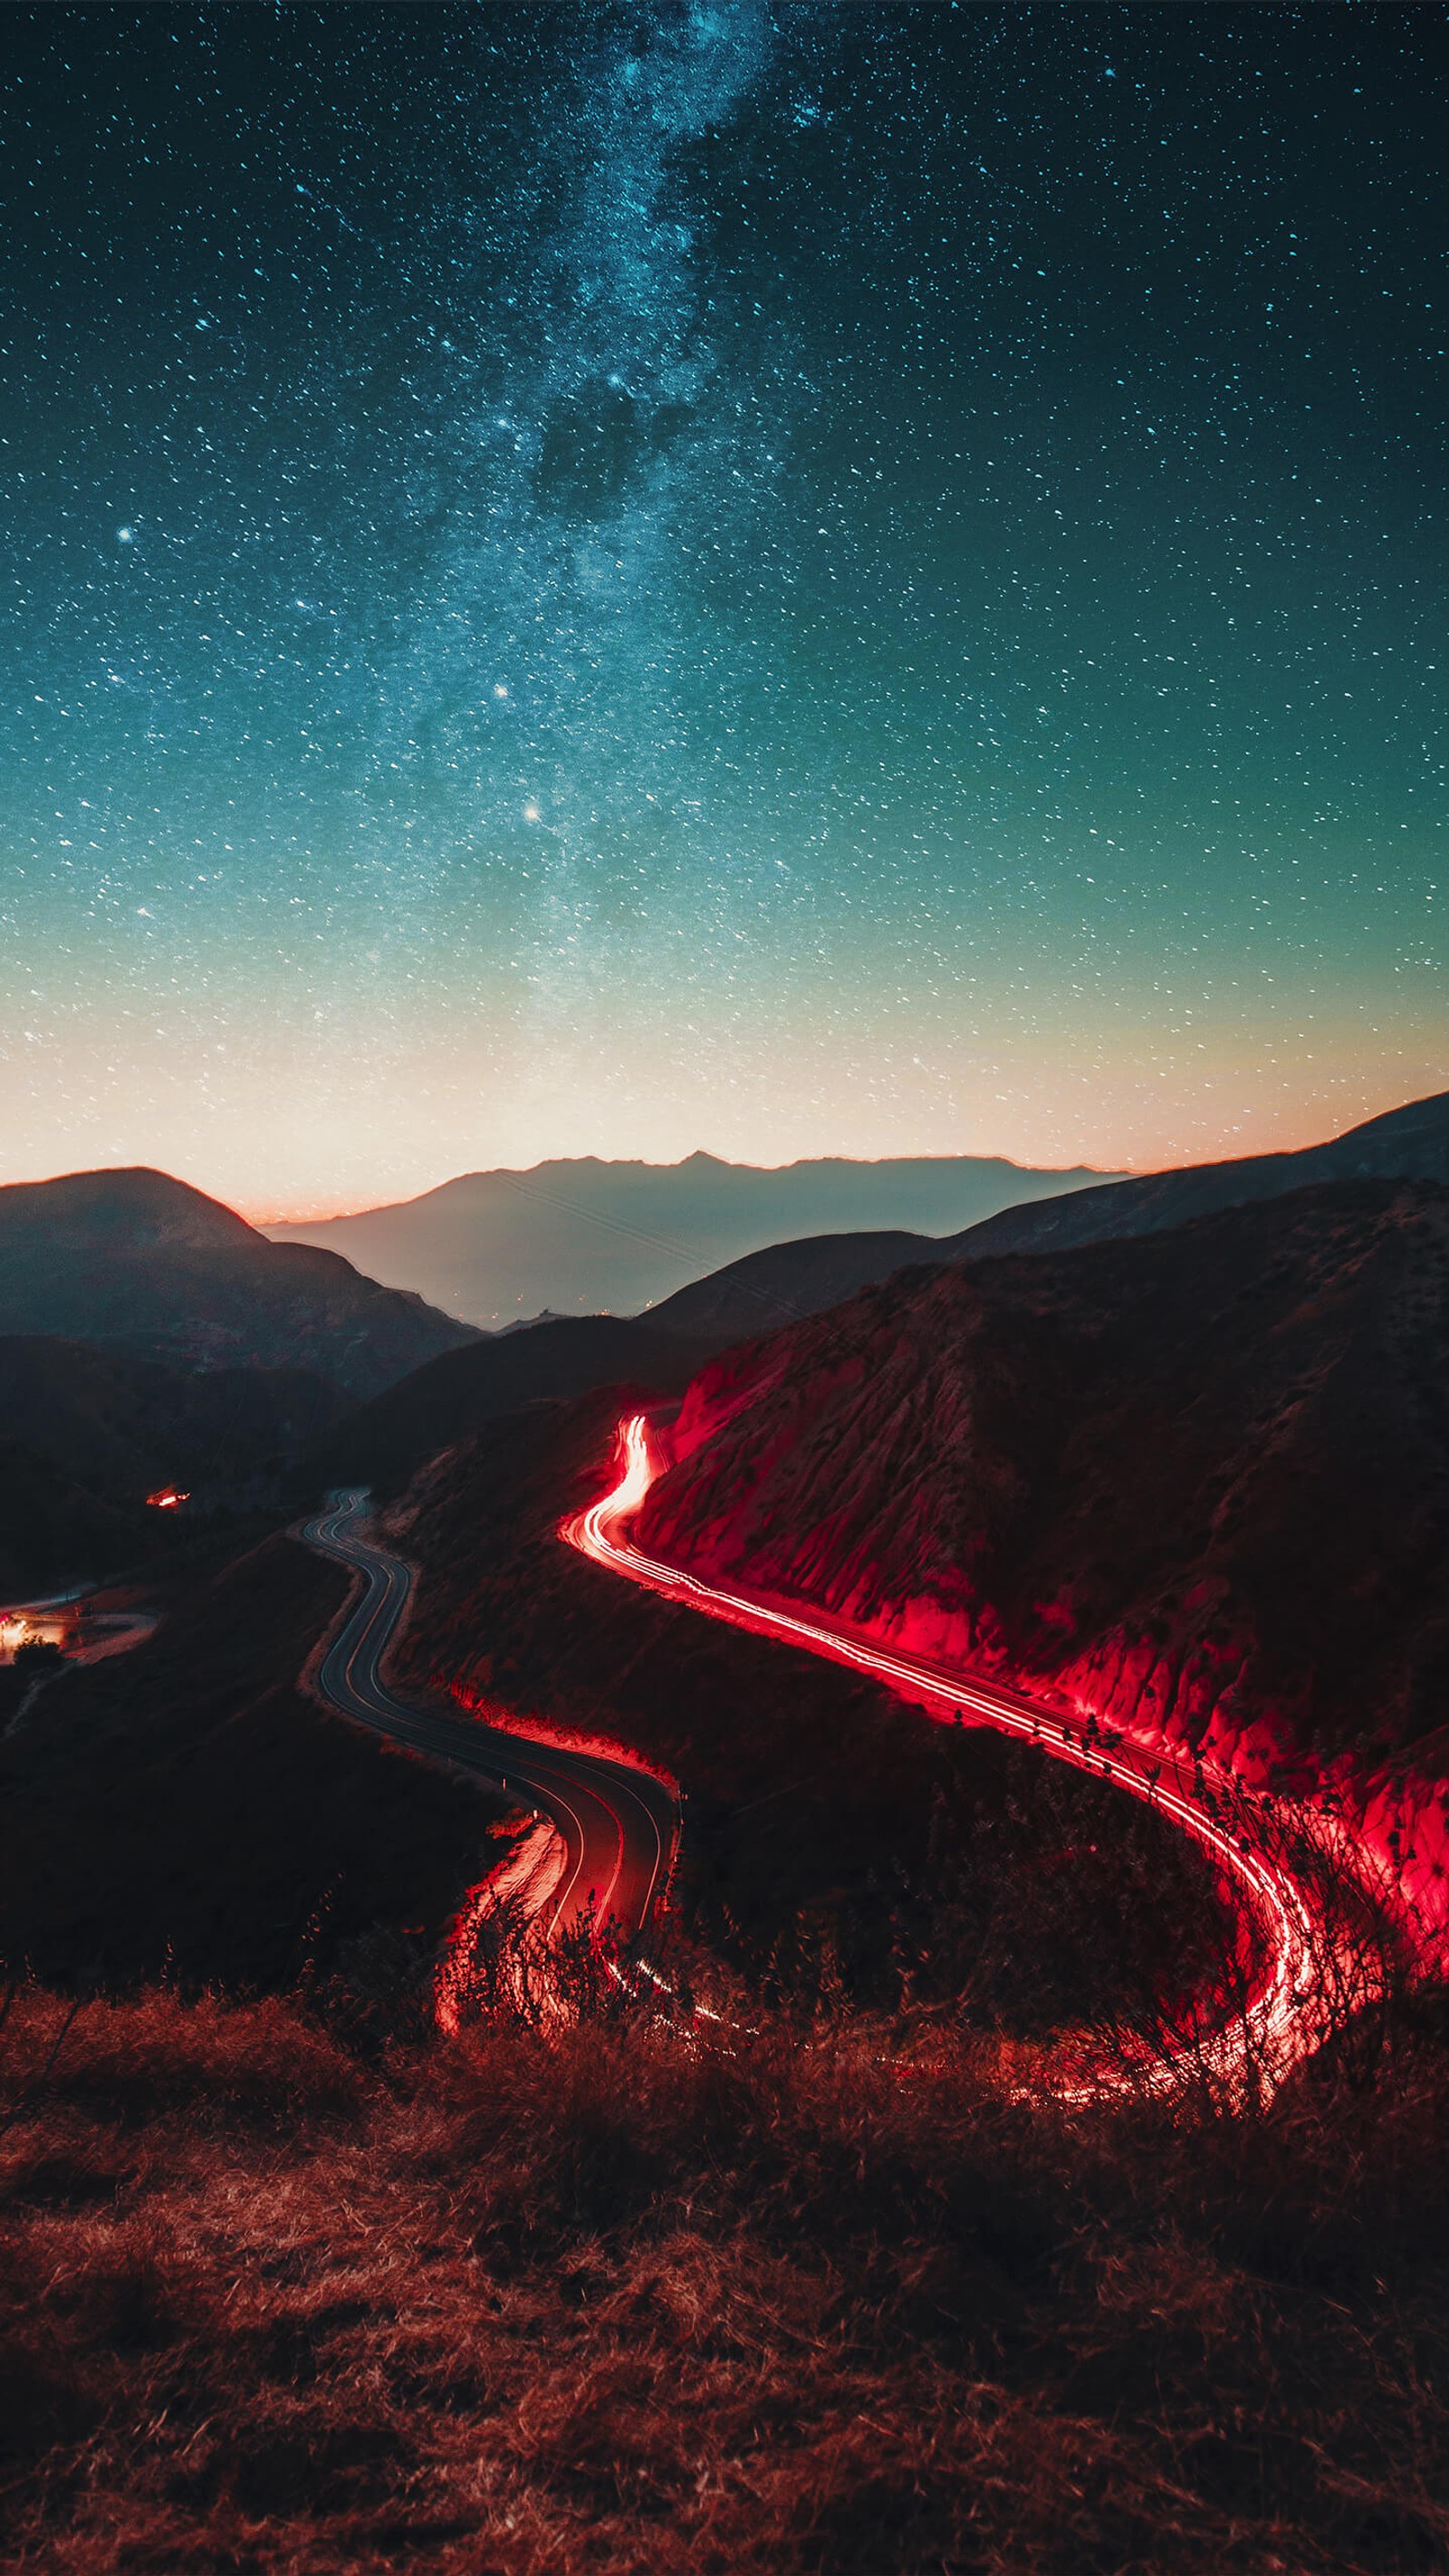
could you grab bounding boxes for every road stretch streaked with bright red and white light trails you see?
[559,1414,1326,2089]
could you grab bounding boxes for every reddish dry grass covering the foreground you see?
[0,1991,1449,2576]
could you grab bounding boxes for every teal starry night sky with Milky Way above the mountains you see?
[0,0,1449,1216]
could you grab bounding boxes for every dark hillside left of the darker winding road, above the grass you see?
[0,1538,504,1991]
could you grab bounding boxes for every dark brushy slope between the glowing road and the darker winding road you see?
[391,1389,1214,2027]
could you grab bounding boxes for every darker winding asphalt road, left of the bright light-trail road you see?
[302,1492,679,1940]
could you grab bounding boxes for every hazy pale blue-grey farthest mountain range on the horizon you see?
[265,1154,1109,1331]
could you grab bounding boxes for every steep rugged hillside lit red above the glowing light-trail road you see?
[641,1180,1449,1759]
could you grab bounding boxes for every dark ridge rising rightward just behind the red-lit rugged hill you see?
[648,1092,1449,1347]
